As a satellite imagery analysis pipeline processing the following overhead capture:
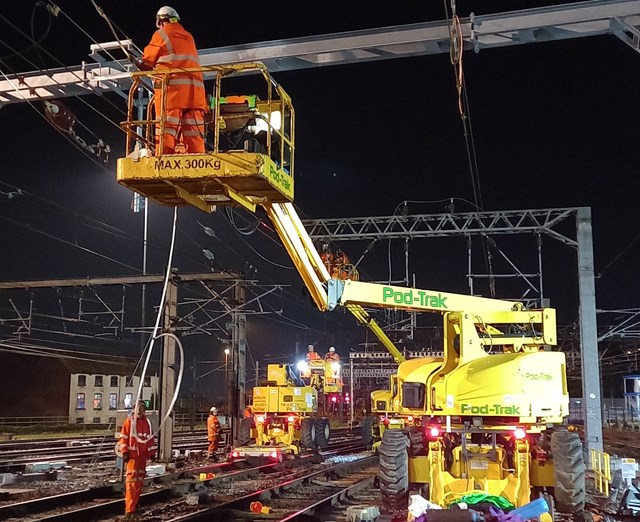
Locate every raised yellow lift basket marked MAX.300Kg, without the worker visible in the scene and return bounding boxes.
[117,64,295,212]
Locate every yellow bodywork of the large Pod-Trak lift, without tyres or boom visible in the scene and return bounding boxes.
[371,308,569,506]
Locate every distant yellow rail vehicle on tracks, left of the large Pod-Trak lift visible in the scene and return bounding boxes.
[231,364,331,461]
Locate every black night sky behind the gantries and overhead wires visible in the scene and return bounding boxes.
[0,0,640,394]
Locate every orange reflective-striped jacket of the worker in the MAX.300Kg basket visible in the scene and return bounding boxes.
[142,22,207,113]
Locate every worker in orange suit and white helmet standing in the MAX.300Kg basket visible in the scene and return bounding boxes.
[141,6,207,154]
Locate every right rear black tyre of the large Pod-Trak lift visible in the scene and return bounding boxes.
[551,431,586,514]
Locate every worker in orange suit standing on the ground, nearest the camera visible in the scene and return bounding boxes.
[117,401,158,520]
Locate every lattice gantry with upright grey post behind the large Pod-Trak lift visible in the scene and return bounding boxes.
[303,207,603,451]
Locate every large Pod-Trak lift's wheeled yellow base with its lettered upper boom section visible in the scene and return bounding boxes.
[342,281,585,512]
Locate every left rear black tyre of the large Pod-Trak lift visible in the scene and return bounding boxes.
[379,430,409,513]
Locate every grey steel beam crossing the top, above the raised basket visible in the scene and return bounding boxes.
[0,0,640,106]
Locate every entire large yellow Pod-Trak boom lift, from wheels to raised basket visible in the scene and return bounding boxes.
[117,64,584,512]
